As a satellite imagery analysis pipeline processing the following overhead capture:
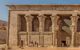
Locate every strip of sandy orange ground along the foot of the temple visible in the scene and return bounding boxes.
[9,47,80,50]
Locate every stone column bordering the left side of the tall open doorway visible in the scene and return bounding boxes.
[51,15,59,47]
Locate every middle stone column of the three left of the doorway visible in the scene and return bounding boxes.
[38,15,45,46]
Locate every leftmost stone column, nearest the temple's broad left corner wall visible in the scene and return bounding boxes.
[26,15,32,46]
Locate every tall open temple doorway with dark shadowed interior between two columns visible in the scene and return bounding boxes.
[57,15,71,47]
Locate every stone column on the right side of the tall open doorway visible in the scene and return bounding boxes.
[70,15,78,47]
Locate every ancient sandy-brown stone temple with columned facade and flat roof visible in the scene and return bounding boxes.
[7,5,80,48]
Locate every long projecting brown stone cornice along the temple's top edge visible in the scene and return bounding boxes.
[8,5,80,11]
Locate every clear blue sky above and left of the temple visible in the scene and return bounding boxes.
[0,0,80,21]
